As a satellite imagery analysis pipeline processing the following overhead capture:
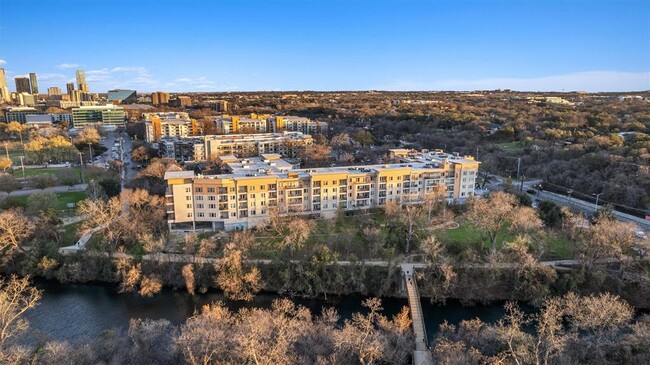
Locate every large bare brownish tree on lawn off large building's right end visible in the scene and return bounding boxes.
[466,191,542,254]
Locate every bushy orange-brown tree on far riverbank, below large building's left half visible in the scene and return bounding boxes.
[214,242,262,301]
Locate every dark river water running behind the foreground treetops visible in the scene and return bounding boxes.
[26,281,504,343]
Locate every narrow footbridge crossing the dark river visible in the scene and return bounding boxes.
[401,264,433,365]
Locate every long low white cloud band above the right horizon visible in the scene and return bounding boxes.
[382,71,650,92]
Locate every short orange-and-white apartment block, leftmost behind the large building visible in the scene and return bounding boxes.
[142,112,201,143]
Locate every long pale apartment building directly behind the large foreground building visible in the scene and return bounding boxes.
[158,132,314,161]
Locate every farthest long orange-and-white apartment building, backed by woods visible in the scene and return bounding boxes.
[214,114,327,134]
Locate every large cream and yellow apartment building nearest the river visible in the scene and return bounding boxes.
[165,151,479,230]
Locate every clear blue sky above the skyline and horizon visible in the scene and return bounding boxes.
[0,0,650,93]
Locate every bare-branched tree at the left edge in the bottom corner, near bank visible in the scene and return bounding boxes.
[0,276,41,363]
